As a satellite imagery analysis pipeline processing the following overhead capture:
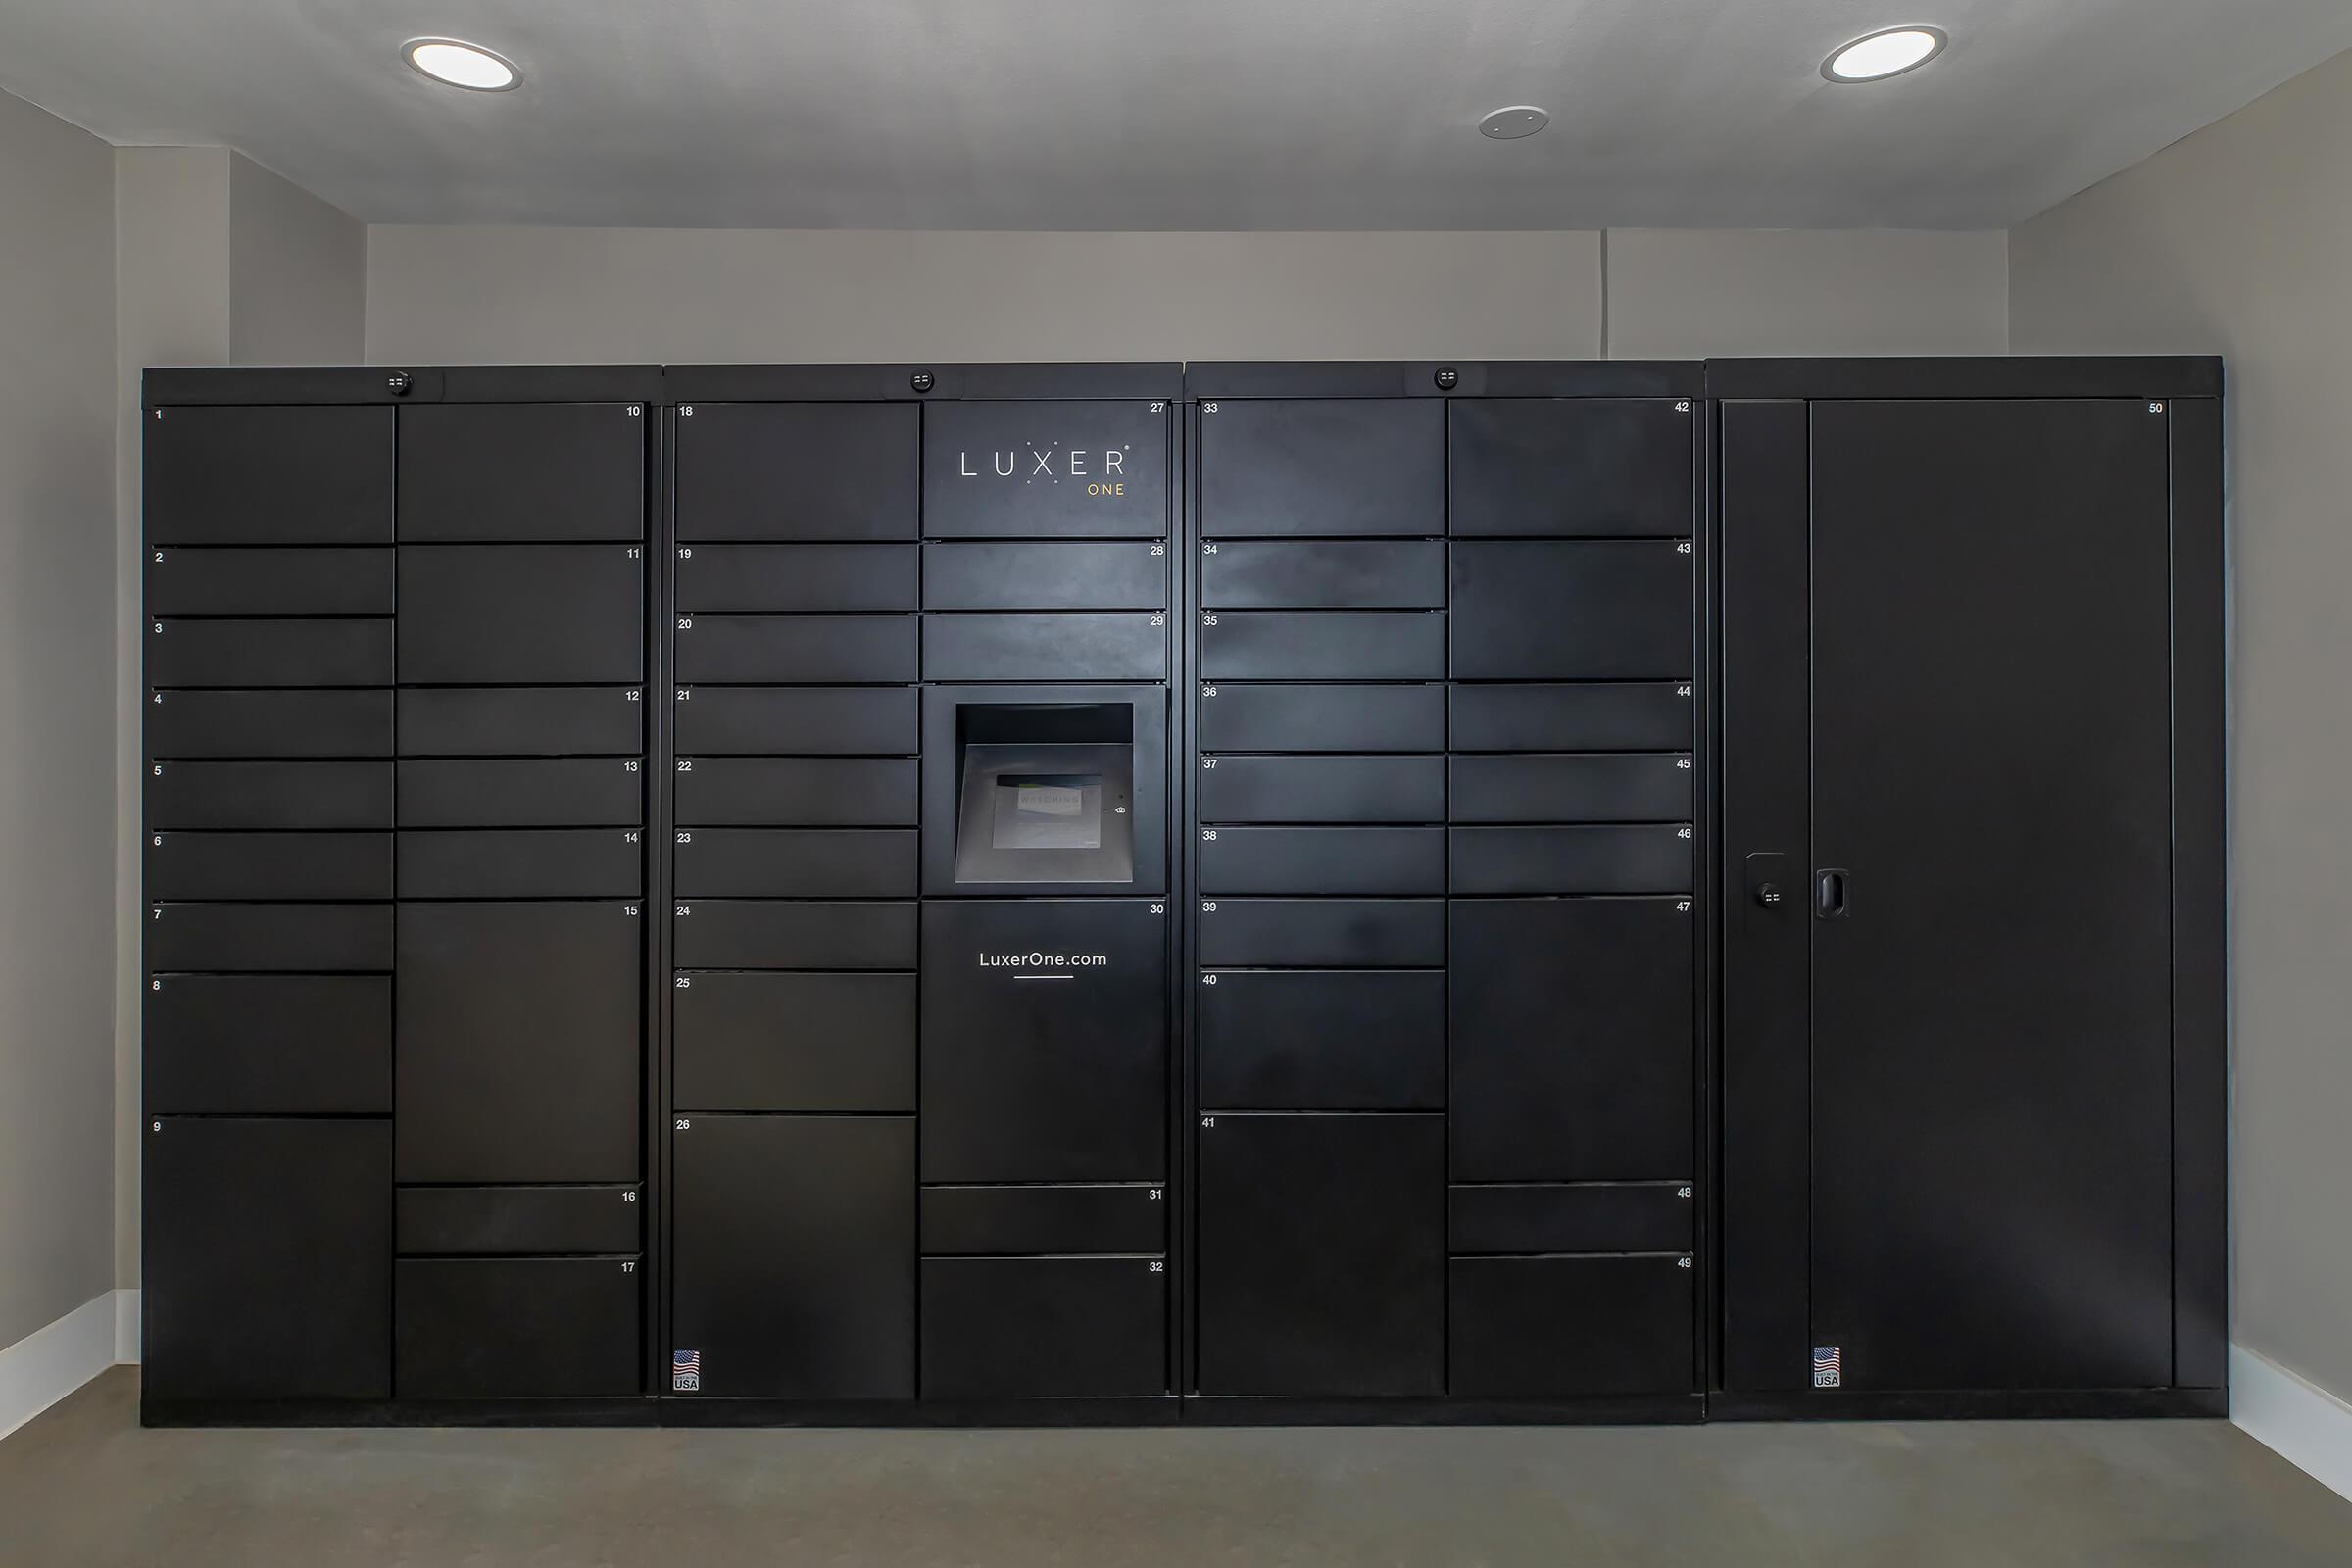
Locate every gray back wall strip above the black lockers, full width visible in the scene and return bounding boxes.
[367,225,2009,362]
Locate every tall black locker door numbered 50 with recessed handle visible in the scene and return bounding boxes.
[1809,400,2174,1390]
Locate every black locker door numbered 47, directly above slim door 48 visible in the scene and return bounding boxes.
[1446,898,1698,1183]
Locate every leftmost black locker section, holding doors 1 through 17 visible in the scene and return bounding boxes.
[143,369,661,1405]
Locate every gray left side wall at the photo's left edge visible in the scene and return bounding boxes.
[0,94,116,1348]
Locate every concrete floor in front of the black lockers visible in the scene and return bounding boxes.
[0,1368,2352,1568]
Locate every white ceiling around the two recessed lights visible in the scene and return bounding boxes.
[0,0,2352,230]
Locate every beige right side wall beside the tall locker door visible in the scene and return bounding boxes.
[2009,54,2352,1396]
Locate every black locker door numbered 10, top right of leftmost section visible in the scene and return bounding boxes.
[400,402,649,543]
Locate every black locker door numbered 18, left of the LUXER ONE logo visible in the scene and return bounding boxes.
[677,402,922,541]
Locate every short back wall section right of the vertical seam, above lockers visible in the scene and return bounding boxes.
[1609,228,2009,360]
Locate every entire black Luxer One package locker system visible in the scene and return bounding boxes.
[141,360,2225,1425]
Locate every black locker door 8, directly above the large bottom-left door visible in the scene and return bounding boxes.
[143,973,393,1116]
